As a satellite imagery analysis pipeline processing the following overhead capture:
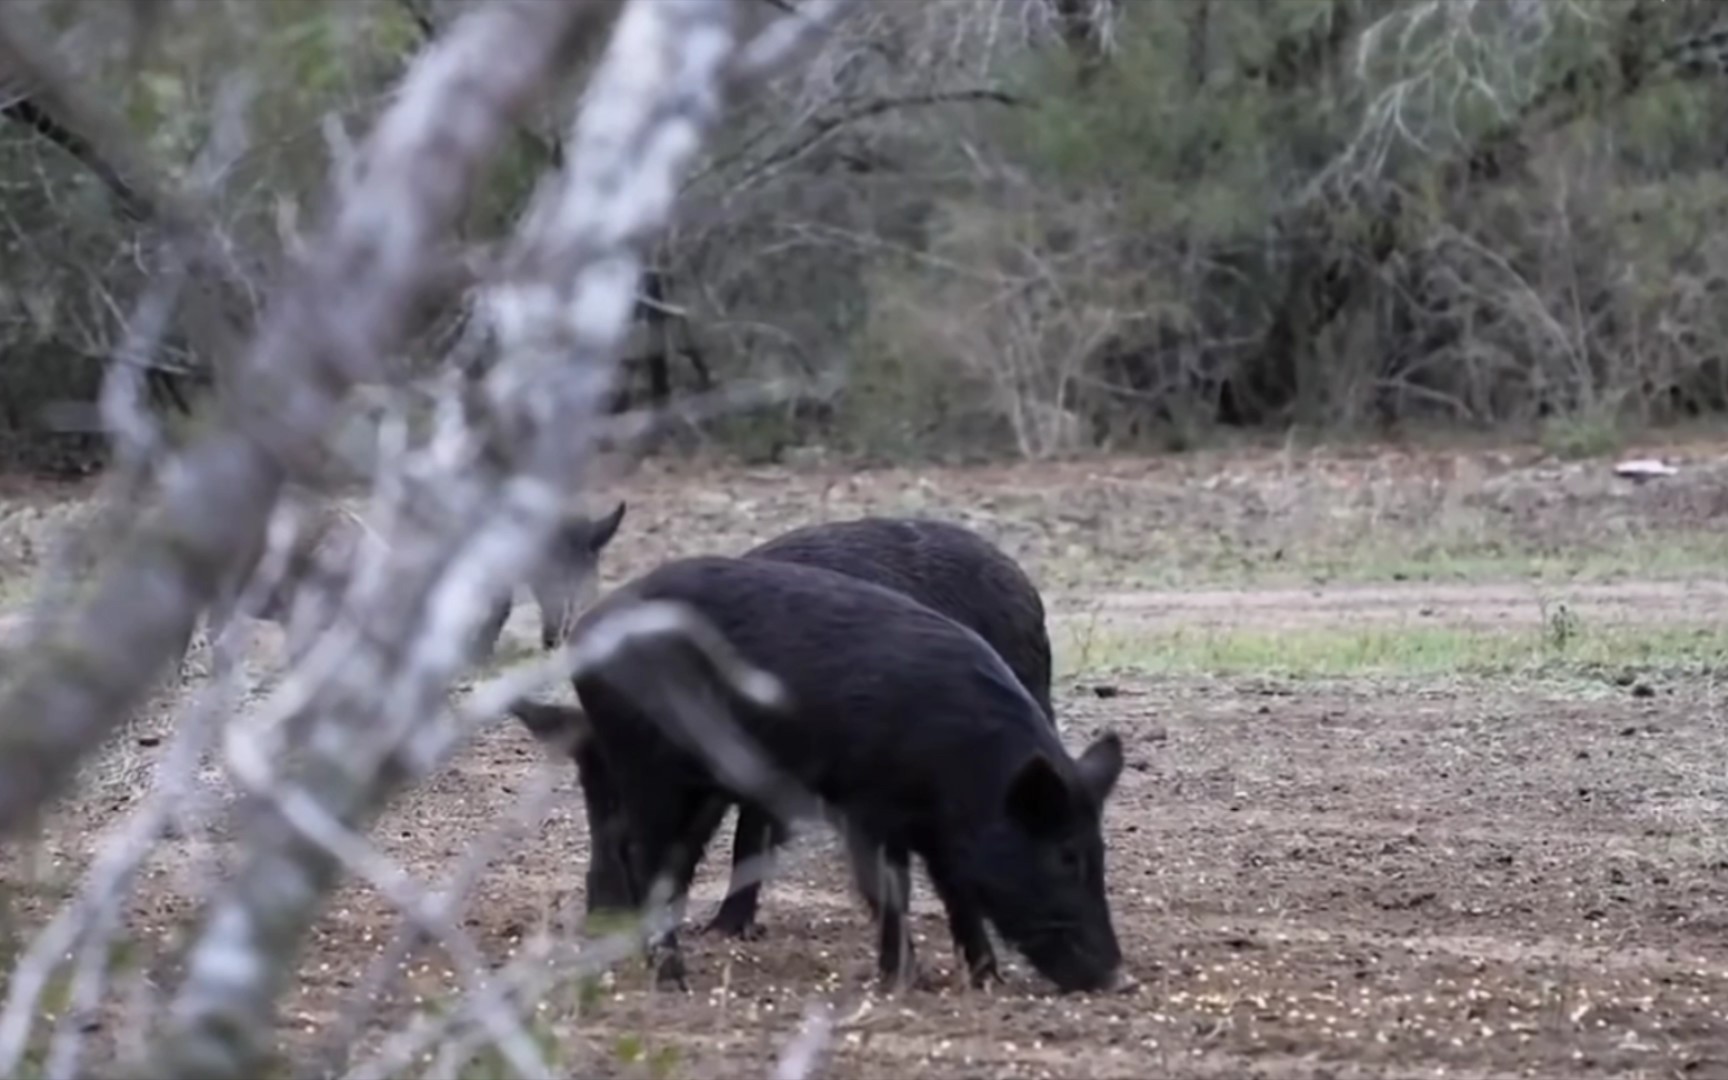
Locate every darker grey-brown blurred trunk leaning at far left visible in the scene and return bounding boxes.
[0,2,615,831]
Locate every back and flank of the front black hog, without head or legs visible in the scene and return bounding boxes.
[577,556,1068,828]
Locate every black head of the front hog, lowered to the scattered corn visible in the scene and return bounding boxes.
[966,731,1121,992]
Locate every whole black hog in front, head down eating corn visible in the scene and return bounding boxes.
[513,556,1121,990]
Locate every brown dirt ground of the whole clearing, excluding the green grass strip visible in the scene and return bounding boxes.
[0,440,1728,1080]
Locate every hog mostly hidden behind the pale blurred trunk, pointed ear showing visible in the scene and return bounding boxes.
[209,501,624,664]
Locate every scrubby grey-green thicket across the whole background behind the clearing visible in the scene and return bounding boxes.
[10,0,1728,468]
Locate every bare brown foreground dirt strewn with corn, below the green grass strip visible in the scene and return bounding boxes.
[226,656,1728,1080]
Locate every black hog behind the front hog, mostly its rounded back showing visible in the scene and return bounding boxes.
[698,517,1056,938]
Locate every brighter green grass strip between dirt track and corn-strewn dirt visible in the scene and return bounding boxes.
[1054,619,1728,679]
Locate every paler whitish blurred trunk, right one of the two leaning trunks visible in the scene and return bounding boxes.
[138,0,853,1077]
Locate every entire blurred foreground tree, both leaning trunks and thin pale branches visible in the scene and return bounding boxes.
[0,0,845,1077]
